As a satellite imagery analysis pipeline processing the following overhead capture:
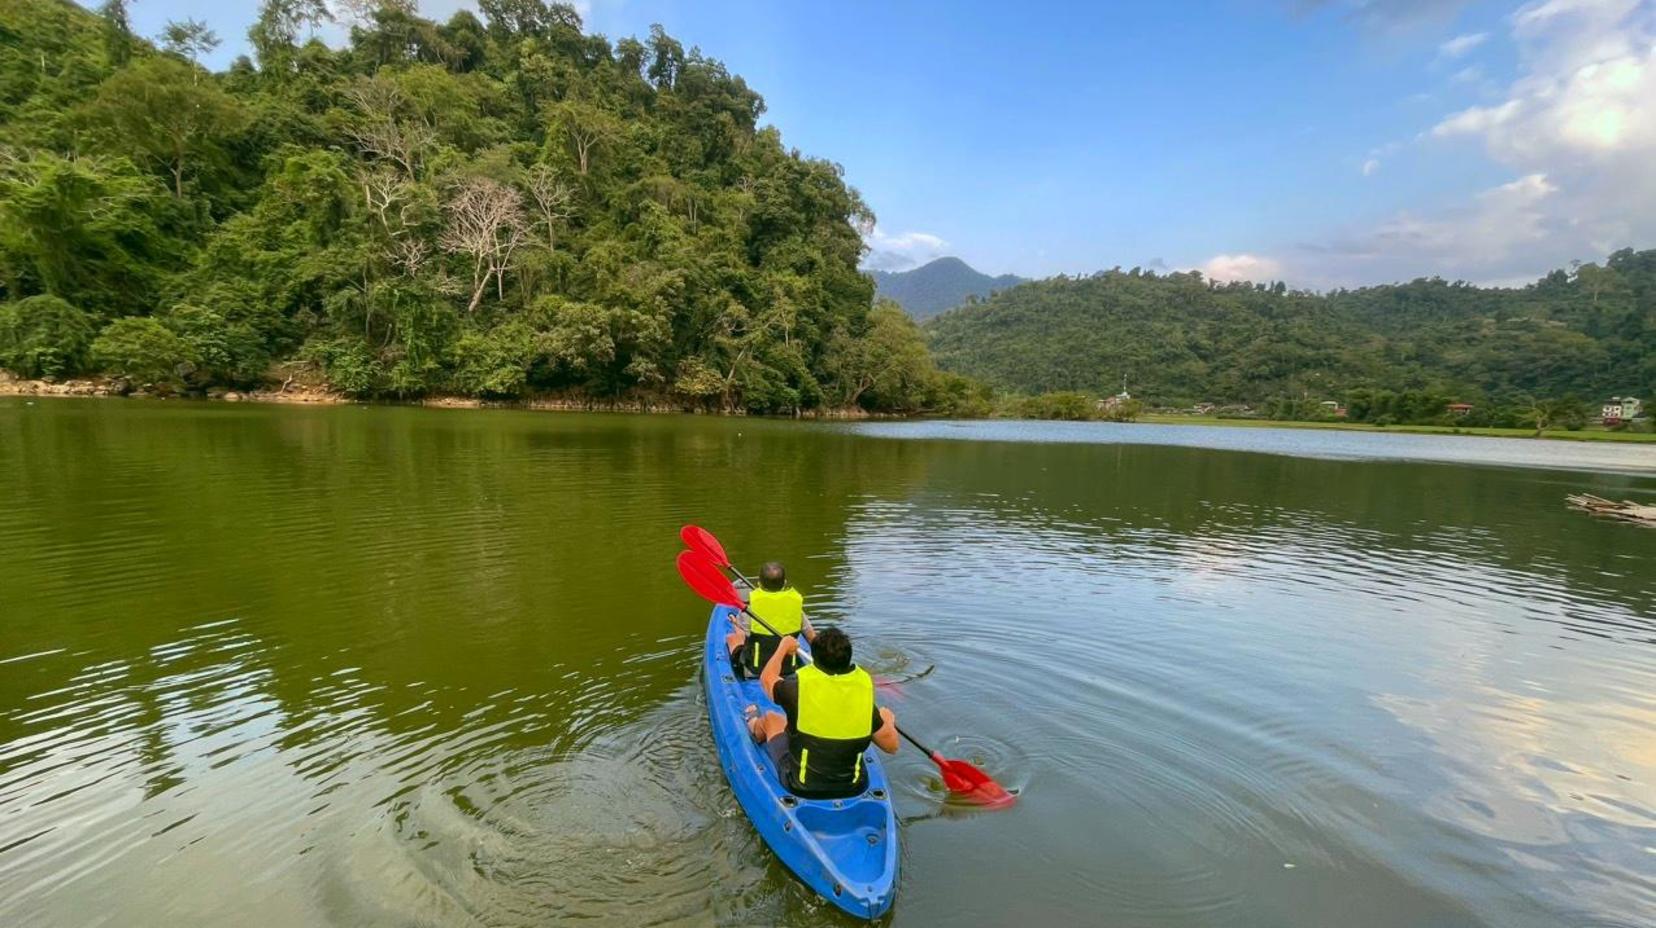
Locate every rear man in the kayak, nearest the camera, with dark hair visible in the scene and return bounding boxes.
[747,626,899,799]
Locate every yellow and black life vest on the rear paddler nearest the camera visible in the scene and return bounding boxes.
[788,665,874,794]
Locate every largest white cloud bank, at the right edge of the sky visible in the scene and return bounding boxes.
[1278,0,1656,287]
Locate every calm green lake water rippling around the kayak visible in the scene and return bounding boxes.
[0,399,1656,928]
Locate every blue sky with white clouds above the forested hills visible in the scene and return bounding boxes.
[122,0,1656,288]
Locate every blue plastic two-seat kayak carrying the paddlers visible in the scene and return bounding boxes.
[702,607,898,918]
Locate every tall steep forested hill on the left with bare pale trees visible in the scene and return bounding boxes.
[0,0,960,411]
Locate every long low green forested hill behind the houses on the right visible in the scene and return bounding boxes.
[926,250,1656,403]
